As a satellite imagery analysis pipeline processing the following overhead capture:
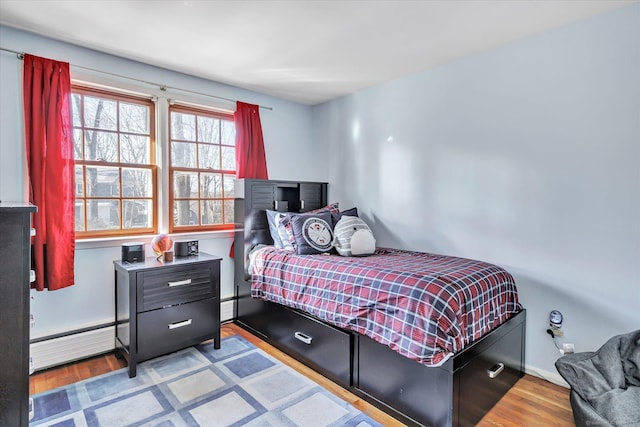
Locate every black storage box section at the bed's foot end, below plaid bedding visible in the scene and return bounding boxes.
[355,311,525,427]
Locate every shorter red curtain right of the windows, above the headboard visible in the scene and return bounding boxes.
[233,101,268,179]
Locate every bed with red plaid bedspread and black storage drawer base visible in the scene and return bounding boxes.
[235,180,525,426]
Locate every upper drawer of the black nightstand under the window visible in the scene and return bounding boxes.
[137,263,215,312]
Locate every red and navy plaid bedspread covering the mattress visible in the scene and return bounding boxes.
[251,246,522,366]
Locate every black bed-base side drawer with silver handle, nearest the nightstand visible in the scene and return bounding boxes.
[267,303,352,387]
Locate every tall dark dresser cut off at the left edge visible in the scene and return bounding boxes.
[0,203,36,426]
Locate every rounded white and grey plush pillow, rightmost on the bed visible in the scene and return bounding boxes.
[333,215,376,256]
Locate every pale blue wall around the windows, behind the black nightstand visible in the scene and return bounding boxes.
[0,26,326,338]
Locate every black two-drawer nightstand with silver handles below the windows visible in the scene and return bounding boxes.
[114,252,221,377]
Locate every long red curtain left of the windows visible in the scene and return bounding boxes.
[24,55,75,291]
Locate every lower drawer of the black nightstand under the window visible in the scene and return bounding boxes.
[138,298,220,360]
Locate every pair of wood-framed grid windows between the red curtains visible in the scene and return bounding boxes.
[72,85,236,238]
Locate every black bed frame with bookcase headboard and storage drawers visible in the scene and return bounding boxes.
[234,180,526,426]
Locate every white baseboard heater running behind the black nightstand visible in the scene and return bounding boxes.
[29,299,234,371]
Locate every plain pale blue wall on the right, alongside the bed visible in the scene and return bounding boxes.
[314,5,640,381]
